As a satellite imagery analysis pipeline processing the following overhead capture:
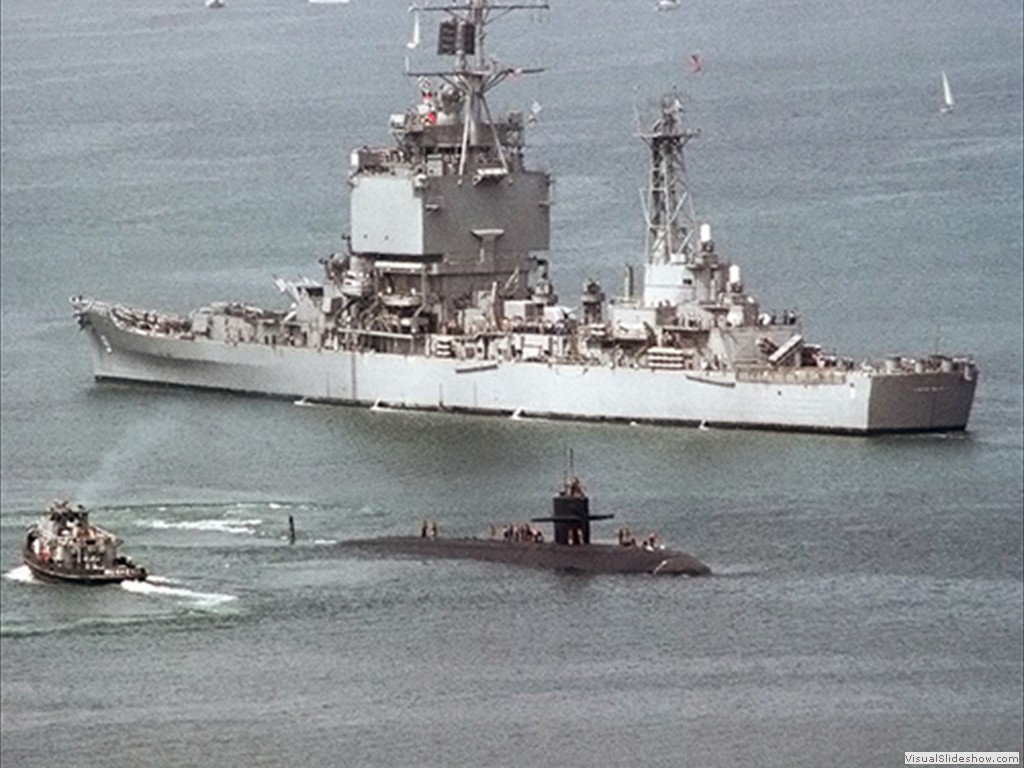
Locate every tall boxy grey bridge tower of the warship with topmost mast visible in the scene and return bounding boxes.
[349,0,552,323]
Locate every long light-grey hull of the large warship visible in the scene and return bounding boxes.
[80,303,977,434]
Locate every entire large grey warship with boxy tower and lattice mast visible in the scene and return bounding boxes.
[72,0,978,434]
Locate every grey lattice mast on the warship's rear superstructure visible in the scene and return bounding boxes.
[640,93,699,264]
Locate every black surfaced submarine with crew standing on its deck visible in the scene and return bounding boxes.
[345,476,711,577]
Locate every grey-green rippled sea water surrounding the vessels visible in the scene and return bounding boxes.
[0,0,1024,767]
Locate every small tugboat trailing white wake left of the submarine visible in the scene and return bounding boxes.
[24,501,146,585]
